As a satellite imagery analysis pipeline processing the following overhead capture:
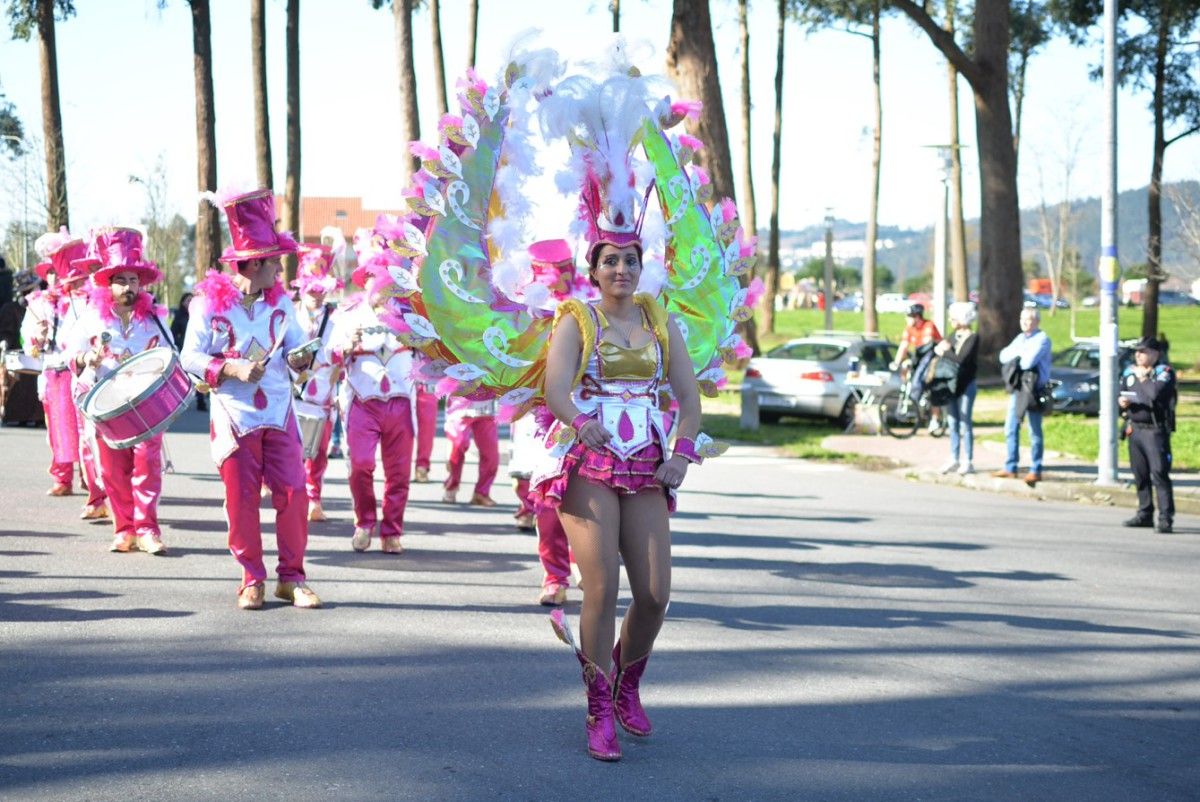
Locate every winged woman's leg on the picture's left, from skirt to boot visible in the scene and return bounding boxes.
[559,475,622,674]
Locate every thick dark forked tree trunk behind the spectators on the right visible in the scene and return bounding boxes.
[892,0,1022,360]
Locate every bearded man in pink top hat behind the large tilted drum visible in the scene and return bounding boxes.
[67,228,174,555]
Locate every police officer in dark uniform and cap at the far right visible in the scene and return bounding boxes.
[1117,337,1175,534]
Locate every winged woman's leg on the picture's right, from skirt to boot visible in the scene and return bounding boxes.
[617,490,671,669]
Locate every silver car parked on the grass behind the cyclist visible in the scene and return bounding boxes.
[744,331,900,426]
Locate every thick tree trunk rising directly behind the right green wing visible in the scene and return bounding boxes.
[667,0,758,353]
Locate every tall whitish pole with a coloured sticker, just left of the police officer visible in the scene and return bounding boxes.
[1096,0,1121,485]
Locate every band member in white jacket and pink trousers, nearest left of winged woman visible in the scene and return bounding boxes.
[334,251,415,555]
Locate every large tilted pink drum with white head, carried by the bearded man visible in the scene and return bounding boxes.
[79,348,194,448]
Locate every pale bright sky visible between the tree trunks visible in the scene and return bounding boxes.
[0,0,1200,250]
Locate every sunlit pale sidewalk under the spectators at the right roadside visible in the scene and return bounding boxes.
[821,426,1200,514]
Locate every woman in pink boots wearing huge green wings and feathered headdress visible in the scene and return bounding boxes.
[369,40,754,760]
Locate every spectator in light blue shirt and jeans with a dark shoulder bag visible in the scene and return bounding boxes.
[991,309,1050,487]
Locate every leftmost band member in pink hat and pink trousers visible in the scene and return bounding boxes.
[20,229,88,496]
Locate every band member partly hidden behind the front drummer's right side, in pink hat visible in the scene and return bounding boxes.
[292,245,342,522]
